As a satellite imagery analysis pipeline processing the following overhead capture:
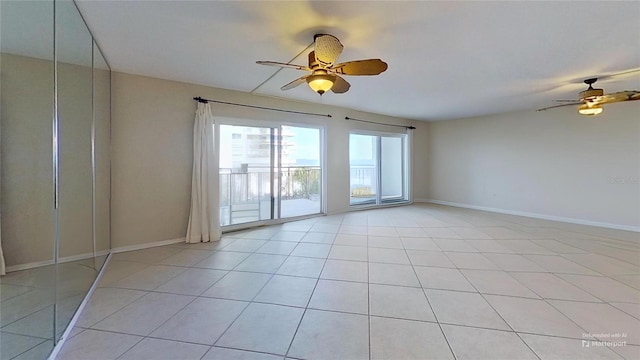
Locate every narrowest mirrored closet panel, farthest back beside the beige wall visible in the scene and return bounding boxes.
[93,42,111,271]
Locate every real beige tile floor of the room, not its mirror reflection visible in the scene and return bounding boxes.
[58,205,640,360]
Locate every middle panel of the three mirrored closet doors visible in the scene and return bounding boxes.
[55,0,97,339]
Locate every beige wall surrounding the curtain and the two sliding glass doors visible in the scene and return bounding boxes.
[111,73,426,248]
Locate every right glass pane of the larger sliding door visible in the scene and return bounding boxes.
[279,126,322,218]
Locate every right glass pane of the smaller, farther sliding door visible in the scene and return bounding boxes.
[380,136,405,203]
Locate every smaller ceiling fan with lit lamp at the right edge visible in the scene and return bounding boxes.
[538,78,640,116]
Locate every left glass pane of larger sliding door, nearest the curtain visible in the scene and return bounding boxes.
[220,125,277,226]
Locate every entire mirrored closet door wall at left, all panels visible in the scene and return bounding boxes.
[0,0,111,359]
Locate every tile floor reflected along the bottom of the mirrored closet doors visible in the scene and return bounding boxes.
[0,256,105,360]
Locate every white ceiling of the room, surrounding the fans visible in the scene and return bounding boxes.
[78,0,640,120]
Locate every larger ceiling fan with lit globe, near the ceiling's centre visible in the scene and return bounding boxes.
[256,34,387,95]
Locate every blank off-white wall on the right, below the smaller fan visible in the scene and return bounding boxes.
[424,102,640,230]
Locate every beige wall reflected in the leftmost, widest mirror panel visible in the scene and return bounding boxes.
[1,53,54,266]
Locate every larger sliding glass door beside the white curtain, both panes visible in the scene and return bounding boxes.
[219,124,322,226]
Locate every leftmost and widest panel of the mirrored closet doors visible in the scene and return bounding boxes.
[0,1,55,359]
